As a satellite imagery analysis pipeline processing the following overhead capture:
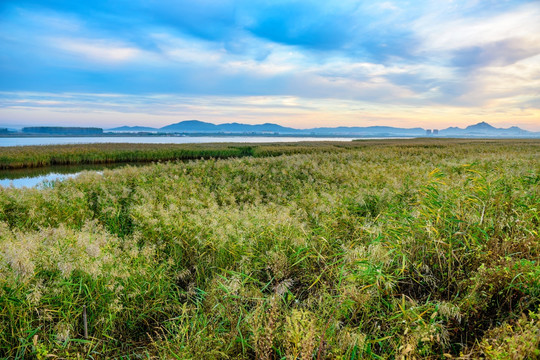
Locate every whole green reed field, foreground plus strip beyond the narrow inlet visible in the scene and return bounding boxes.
[0,139,540,359]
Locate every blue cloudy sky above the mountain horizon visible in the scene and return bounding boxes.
[0,0,540,131]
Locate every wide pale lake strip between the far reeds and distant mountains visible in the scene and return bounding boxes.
[0,136,362,146]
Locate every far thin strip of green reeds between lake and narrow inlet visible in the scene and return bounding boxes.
[0,139,534,170]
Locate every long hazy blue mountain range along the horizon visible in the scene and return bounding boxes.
[104,120,540,137]
